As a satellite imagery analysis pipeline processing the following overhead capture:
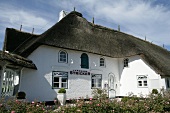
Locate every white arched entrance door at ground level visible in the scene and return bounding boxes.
[108,74,116,98]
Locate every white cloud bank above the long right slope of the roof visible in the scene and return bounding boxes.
[71,0,170,45]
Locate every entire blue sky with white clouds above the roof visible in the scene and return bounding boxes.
[0,0,170,50]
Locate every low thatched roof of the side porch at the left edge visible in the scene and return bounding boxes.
[0,51,37,69]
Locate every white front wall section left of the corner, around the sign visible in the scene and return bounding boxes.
[20,46,120,101]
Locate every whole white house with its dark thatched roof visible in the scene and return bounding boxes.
[1,11,170,101]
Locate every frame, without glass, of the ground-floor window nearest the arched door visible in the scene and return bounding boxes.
[91,73,102,89]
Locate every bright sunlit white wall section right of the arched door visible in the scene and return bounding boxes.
[119,56,163,96]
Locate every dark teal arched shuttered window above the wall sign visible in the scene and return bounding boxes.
[81,53,89,69]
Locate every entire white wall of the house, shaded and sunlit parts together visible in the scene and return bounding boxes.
[20,46,166,101]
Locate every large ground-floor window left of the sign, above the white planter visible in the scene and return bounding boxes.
[52,71,68,88]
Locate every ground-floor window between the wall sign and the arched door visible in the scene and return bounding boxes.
[91,74,102,88]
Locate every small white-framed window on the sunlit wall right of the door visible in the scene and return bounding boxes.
[137,75,148,87]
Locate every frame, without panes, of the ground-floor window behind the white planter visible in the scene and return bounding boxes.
[52,71,68,89]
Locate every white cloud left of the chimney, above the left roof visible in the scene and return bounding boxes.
[0,4,52,33]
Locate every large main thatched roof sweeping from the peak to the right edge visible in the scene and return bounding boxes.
[4,11,170,76]
